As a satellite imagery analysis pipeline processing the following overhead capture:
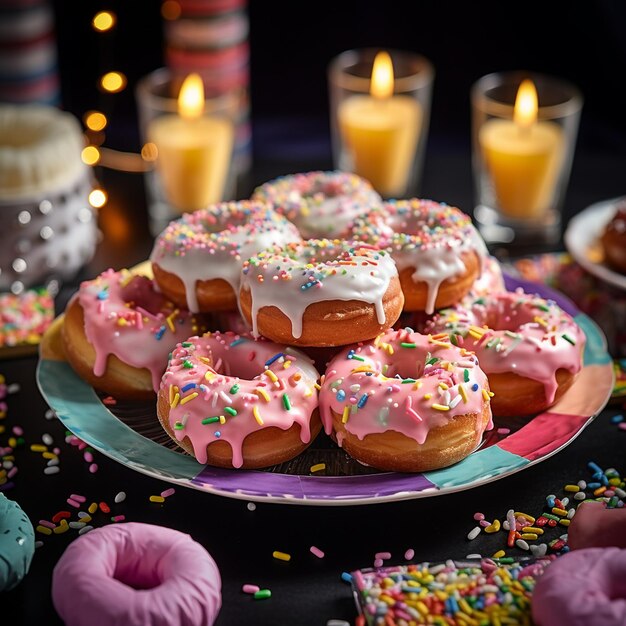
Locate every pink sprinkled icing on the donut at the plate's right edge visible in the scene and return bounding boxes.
[426,289,585,402]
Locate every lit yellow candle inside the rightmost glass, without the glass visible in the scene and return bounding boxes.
[479,80,564,219]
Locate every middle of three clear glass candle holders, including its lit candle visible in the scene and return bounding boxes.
[328,48,435,198]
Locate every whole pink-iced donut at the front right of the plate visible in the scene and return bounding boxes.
[320,329,493,472]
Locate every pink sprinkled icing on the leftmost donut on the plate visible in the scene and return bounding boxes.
[75,269,198,391]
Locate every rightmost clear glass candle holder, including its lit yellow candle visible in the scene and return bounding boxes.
[471,71,583,246]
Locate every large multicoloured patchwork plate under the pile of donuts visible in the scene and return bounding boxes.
[37,277,614,506]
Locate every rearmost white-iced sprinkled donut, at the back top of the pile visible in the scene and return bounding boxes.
[252,171,382,239]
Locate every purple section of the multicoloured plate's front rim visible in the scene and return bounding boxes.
[191,466,436,500]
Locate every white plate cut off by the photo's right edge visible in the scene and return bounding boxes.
[564,196,626,289]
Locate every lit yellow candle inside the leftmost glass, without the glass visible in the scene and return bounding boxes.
[148,74,233,212]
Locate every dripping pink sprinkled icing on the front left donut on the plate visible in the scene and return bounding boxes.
[161,332,319,467]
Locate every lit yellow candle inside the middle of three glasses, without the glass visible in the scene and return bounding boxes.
[337,52,422,198]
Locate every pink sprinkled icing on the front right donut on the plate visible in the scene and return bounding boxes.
[320,329,493,444]
